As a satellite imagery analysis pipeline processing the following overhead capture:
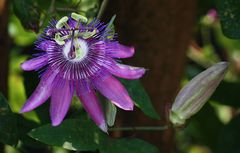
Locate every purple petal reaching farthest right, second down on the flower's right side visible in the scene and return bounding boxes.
[107,62,145,79]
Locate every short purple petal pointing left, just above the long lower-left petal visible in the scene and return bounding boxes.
[21,54,48,71]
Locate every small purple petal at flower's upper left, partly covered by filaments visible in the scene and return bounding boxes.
[36,40,56,51]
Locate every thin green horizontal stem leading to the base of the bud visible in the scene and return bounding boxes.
[108,125,169,131]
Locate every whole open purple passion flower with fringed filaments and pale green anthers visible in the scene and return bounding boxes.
[21,13,145,132]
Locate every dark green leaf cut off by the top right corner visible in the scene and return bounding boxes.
[215,0,240,39]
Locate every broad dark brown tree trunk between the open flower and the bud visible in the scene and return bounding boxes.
[103,0,196,153]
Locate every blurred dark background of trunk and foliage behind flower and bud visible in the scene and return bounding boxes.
[0,0,240,153]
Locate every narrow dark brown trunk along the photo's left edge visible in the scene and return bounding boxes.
[0,0,9,97]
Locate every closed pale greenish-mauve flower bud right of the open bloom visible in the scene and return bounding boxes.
[169,62,228,125]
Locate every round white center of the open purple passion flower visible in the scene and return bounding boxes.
[63,38,89,62]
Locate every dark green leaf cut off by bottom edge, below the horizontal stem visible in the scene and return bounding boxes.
[100,139,159,153]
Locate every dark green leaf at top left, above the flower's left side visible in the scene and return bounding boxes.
[13,0,40,32]
